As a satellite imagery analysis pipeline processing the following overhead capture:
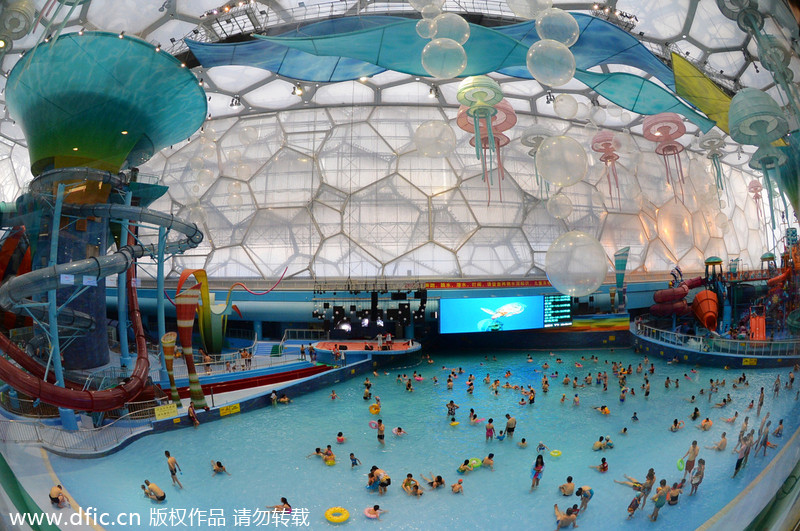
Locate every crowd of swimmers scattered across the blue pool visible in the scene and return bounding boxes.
[79,349,800,529]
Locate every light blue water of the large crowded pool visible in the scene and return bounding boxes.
[51,351,800,530]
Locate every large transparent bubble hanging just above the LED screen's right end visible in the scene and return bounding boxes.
[545,231,608,297]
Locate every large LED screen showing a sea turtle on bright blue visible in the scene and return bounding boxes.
[439,295,572,334]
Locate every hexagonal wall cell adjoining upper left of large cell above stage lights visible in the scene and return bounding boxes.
[318,122,396,193]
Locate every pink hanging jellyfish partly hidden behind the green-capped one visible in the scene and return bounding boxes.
[456,100,517,204]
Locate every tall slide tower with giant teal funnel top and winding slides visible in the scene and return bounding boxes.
[0,32,206,428]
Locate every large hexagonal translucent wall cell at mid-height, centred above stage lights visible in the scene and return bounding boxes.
[344,174,430,262]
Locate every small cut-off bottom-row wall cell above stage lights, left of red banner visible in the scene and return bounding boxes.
[311,234,383,278]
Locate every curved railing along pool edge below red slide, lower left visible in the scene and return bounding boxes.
[0,412,152,453]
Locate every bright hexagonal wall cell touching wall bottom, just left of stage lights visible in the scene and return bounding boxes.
[242,208,321,279]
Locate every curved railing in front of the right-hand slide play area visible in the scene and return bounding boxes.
[632,322,800,357]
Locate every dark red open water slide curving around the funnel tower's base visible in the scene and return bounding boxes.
[0,235,150,411]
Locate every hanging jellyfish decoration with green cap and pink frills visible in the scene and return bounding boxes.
[456,76,517,206]
